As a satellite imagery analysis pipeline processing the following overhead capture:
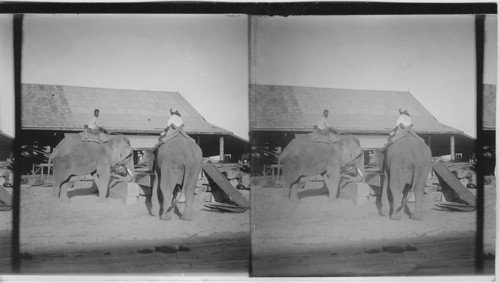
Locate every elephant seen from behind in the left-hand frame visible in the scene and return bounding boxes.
[141,134,203,221]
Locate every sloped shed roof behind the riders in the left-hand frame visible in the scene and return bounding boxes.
[21,84,232,135]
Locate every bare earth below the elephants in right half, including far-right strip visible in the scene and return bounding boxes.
[251,182,495,276]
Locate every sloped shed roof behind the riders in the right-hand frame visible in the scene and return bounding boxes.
[249,84,463,134]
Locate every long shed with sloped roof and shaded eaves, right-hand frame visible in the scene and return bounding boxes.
[249,84,475,166]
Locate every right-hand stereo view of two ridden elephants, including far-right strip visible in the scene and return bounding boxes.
[249,15,497,277]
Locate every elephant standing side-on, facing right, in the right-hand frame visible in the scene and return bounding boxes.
[278,134,364,202]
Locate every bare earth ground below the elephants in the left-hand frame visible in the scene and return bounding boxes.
[15,187,250,274]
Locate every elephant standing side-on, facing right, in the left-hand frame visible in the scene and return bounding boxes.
[48,135,134,202]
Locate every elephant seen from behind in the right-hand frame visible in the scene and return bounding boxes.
[377,134,432,220]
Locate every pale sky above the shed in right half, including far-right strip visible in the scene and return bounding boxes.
[251,16,497,137]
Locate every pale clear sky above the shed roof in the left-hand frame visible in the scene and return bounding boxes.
[22,15,248,139]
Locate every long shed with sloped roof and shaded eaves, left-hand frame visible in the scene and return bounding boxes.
[21,84,249,169]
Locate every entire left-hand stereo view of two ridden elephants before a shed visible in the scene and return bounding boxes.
[8,15,250,275]
